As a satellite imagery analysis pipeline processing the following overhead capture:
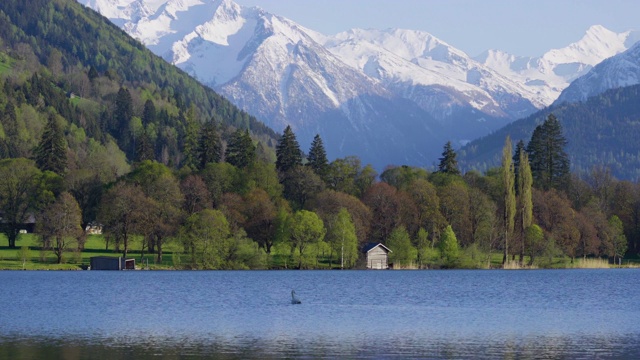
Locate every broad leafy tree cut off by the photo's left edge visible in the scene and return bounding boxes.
[0,158,48,249]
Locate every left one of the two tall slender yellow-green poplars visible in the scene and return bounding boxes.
[501,136,516,265]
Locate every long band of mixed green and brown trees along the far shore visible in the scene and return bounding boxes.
[0,115,640,269]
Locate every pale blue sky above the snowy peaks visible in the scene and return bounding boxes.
[235,0,640,56]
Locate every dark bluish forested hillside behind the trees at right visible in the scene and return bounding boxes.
[459,85,640,180]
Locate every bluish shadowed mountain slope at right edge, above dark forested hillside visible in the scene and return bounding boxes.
[556,43,640,103]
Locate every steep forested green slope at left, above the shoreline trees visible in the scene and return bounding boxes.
[0,0,277,167]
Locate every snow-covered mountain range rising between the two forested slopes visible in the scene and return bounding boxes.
[79,0,640,169]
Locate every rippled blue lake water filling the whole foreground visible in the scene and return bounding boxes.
[0,269,640,360]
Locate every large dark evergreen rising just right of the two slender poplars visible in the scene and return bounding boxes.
[527,114,569,190]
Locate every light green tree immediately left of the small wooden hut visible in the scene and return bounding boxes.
[327,208,358,269]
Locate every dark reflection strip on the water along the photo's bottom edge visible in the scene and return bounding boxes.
[0,334,640,360]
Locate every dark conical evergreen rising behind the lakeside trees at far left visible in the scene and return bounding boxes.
[34,114,67,175]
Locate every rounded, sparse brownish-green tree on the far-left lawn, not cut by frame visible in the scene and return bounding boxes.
[38,192,83,264]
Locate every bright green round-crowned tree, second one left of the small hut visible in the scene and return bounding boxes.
[289,210,326,269]
